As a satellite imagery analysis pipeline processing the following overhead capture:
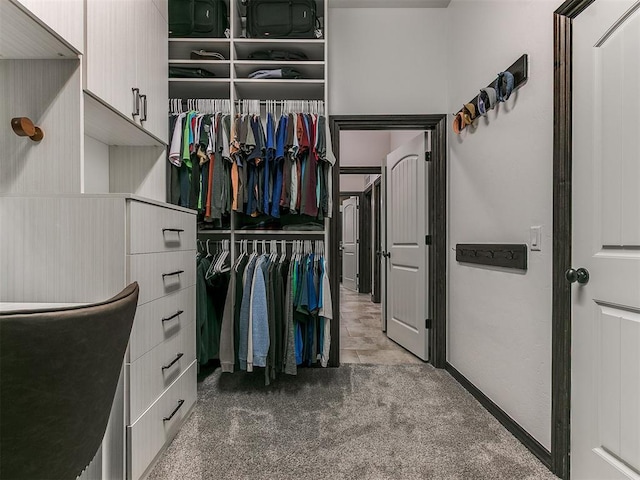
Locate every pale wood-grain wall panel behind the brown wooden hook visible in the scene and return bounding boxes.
[0,60,82,194]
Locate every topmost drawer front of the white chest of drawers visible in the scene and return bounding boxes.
[127,201,196,254]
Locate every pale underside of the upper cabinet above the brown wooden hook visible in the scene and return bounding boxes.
[0,0,79,60]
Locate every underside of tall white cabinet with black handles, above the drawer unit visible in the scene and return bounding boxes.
[84,90,166,148]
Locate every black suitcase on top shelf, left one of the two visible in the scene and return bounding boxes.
[169,0,229,38]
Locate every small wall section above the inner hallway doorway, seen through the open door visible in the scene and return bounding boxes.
[340,130,390,167]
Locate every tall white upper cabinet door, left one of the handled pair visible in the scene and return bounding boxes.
[86,0,139,122]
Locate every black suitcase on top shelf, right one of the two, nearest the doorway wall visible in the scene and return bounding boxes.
[246,0,317,38]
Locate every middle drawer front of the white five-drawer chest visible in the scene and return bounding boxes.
[127,286,196,363]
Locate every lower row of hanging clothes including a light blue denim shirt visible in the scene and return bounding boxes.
[218,241,333,385]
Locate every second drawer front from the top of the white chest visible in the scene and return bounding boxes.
[127,250,196,305]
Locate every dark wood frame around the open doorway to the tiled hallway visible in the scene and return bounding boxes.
[329,114,448,368]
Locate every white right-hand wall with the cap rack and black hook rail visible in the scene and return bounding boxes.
[446,0,562,449]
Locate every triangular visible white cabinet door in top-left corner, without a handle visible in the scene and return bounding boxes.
[13,0,84,52]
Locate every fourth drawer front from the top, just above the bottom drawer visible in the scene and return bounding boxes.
[127,322,196,422]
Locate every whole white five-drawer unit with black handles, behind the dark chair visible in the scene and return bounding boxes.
[0,195,196,480]
